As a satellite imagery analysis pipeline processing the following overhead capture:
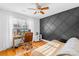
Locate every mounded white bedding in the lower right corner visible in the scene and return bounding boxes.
[57,37,79,56]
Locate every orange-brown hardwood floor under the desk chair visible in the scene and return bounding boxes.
[0,40,47,56]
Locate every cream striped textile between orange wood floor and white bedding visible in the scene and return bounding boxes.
[32,41,64,56]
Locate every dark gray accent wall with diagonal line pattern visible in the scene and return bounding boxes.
[40,7,79,41]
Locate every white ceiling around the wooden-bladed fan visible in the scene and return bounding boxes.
[0,3,79,18]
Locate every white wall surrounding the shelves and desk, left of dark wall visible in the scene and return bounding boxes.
[0,10,40,50]
